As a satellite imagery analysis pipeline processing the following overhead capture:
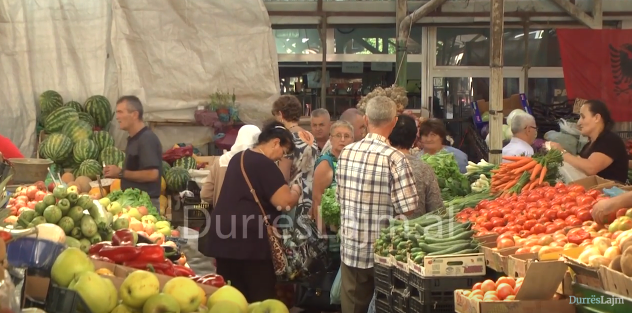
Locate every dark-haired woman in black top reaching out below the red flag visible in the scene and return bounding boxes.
[551,100,628,183]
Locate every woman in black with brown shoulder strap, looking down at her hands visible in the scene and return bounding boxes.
[208,122,301,303]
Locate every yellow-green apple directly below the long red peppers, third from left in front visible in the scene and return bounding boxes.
[119,271,160,309]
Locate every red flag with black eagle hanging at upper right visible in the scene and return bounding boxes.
[557,29,632,122]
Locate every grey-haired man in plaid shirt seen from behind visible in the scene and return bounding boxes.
[336,96,419,313]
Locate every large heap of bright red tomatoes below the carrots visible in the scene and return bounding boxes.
[456,183,615,238]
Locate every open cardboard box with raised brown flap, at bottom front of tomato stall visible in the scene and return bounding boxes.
[454,261,575,313]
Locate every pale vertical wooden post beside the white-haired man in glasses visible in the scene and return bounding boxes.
[489,0,505,164]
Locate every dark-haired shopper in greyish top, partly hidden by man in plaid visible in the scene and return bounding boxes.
[388,114,443,217]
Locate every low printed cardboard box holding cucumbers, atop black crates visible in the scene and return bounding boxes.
[408,253,486,277]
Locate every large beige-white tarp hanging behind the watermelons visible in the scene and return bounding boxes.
[0,0,279,155]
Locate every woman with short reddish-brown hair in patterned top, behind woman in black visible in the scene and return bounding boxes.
[272,95,318,217]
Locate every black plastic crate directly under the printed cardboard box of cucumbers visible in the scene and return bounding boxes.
[408,273,483,304]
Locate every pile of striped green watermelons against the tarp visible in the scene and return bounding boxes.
[39,90,125,180]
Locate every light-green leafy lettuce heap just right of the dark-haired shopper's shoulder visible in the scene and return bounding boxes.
[421,150,471,201]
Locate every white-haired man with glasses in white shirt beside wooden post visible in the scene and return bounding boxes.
[503,114,538,162]
